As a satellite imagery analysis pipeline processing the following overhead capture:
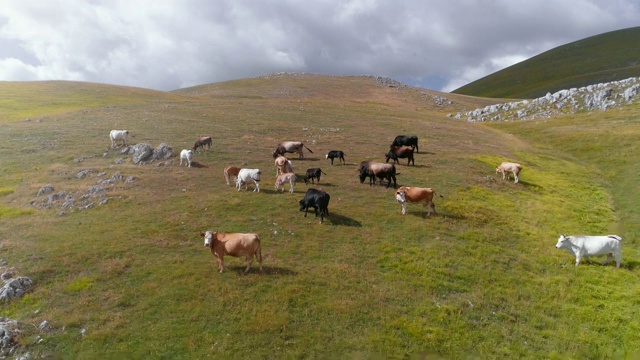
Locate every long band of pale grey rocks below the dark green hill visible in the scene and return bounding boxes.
[447,77,640,122]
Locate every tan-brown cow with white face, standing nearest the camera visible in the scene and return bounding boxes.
[200,230,262,274]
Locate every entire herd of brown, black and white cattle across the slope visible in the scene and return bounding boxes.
[109,130,622,273]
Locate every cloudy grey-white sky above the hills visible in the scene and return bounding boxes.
[0,0,640,91]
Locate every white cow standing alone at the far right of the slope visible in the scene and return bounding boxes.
[556,235,622,268]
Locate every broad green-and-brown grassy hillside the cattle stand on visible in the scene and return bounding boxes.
[0,75,640,358]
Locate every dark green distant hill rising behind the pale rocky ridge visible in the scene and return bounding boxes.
[453,27,640,99]
